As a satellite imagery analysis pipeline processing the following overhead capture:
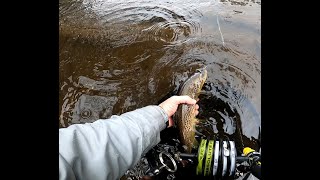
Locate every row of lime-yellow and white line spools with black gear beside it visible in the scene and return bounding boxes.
[190,139,261,179]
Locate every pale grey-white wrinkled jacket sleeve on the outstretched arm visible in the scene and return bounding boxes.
[59,105,168,180]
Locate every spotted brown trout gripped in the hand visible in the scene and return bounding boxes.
[176,68,207,153]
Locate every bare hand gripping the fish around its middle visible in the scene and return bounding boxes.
[159,96,199,127]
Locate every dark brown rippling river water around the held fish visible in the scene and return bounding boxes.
[59,0,261,179]
